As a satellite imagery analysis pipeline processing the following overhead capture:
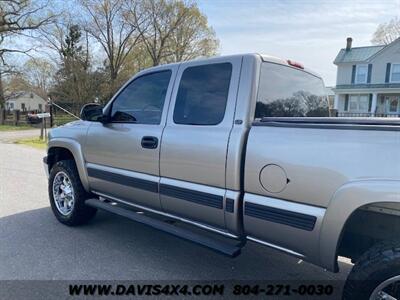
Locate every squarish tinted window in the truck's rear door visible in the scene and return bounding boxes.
[174,63,232,125]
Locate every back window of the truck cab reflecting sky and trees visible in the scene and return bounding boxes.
[255,63,329,118]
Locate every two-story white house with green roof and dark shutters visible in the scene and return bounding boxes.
[333,38,400,117]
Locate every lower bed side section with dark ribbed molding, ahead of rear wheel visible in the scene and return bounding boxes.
[243,193,326,264]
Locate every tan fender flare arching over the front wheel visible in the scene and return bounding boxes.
[47,138,89,192]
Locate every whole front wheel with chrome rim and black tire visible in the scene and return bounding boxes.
[49,160,96,226]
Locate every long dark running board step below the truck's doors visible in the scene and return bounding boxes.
[85,199,242,257]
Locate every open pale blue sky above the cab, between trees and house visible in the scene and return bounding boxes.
[198,0,400,86]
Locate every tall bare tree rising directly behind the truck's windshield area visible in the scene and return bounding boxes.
[80,0,141,92]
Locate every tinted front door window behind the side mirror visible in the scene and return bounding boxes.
[111,71,171,124]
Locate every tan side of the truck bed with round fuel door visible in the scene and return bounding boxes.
[244,118,400,266]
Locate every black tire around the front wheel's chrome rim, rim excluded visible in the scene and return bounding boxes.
[48,160,97,226]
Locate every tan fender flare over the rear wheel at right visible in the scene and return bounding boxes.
[319,180,400,272]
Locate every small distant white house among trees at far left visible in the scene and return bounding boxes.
[6,91,46,111]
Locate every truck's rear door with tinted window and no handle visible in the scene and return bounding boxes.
[160,56,242,227]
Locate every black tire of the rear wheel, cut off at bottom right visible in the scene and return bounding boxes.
[343,240,400,300]
